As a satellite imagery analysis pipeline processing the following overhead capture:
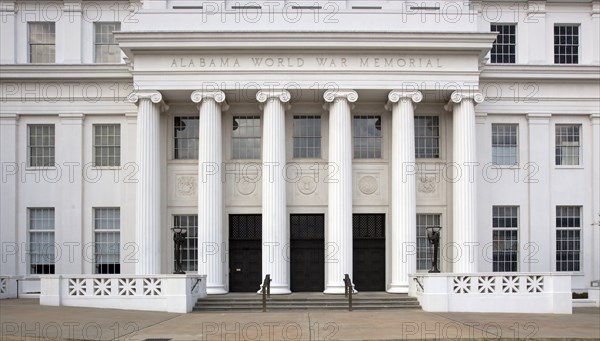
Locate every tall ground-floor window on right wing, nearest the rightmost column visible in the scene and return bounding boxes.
[492,206,519,272]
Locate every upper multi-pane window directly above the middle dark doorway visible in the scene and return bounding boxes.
[294,116,321,158]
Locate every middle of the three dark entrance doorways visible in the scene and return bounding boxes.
[290,214,325,292]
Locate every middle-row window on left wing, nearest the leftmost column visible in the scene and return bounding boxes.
[94,124,121,167]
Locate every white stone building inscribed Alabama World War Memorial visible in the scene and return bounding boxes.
[0,0,600,293]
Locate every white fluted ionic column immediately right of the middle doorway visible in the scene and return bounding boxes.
[323,90,358,294]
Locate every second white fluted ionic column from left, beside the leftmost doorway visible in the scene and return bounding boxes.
[192,90,228,295]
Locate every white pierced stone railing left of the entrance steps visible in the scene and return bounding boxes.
[40,275,206,313]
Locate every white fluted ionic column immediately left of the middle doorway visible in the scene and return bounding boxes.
[256,90,291,294]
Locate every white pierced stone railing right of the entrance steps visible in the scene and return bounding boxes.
[409,272,572,314]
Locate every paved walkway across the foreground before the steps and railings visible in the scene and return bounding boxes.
[0,299,600,341]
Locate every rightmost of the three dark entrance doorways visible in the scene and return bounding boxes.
[352,214,385,291]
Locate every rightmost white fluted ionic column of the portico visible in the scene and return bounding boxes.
[442,91,483,273]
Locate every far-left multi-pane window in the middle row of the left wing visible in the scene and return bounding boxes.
[27,124,54,167]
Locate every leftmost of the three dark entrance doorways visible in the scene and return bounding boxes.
[229,214,262,292]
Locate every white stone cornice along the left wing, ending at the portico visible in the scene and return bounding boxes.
[0,64,133,81]
